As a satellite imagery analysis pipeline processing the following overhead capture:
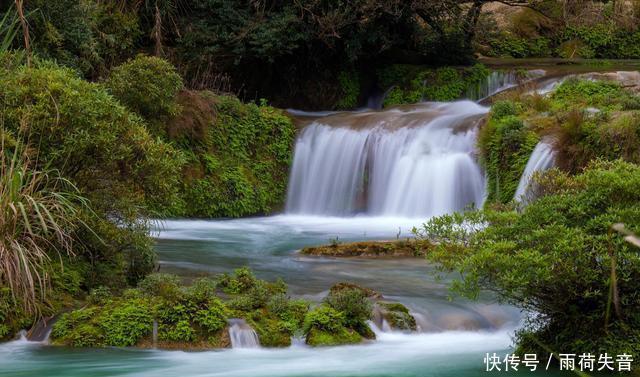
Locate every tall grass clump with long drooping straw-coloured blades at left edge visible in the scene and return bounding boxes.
[0,135,88,315]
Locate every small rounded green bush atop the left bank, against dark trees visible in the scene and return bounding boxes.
[105,55,183,120]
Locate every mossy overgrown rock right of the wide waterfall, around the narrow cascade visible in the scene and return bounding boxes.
[479,79,640,203]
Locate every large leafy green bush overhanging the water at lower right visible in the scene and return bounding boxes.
[424,161,640,354]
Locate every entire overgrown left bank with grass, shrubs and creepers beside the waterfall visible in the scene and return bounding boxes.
[0,49,294,337]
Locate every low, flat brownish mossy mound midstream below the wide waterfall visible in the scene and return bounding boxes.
[301,240,429,258]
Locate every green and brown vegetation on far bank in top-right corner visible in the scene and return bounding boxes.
[475,0,640,59]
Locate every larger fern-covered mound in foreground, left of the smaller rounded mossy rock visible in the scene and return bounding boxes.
[51,268,308,349]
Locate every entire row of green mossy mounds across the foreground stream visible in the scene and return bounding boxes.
[51,268,415,349]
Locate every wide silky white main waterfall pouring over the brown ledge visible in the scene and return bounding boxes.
[286,101,487,217]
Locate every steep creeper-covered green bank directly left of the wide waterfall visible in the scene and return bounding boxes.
[165,92,295,217]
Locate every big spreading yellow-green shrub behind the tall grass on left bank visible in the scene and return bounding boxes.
[0,62,182,287]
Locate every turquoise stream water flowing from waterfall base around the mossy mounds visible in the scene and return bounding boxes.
[0,216,568,377]
